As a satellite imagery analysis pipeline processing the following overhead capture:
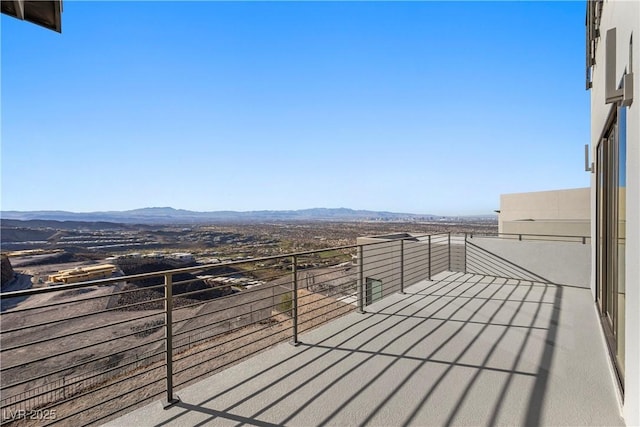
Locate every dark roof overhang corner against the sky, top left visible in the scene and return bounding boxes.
[2,0,62,33]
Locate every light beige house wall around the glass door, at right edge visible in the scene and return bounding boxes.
[592,0,640,425]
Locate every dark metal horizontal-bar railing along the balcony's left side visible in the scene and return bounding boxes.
[0,233,461,425]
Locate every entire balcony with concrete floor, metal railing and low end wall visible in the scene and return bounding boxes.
[1,233,624,426]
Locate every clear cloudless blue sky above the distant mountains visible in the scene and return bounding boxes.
[1,1,589,214]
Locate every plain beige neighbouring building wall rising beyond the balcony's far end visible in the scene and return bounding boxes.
[498,188,591,236]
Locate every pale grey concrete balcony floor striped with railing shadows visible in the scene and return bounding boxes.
[109,272,624,426]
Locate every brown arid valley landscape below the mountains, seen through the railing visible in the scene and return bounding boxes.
[2,219,497,425]
